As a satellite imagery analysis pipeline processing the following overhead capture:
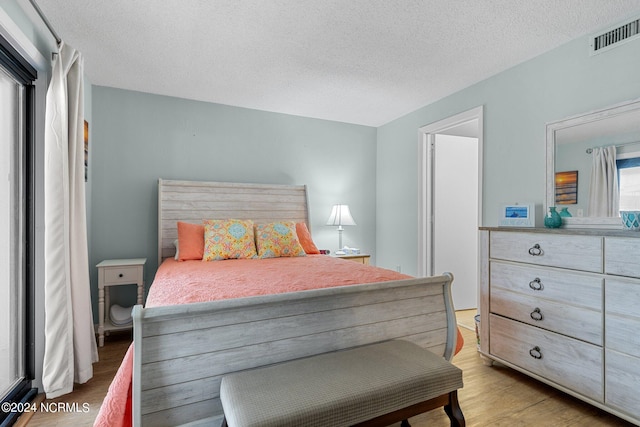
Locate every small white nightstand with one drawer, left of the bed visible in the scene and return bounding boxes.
[96,258,147,347]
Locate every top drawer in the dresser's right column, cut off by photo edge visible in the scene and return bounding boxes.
[604,237,640,278]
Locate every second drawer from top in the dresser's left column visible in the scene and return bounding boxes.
[490,261,604,311]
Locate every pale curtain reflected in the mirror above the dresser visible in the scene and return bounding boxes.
[588,146,620,217]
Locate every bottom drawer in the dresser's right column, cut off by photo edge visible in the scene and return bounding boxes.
[605,350,640,417]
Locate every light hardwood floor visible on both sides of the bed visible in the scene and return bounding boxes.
[17,310,632,427]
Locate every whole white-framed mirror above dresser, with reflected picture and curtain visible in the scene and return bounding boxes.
[546,100,640,226]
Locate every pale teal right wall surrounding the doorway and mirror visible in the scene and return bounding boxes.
[376,30,640,274]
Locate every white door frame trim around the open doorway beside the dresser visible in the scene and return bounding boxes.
[418,105,484,277]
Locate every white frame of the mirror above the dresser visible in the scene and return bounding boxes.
[544,98,640,229]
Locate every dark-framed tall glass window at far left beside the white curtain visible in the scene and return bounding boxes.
[0,37,36,426]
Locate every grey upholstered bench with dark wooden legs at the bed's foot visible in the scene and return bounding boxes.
[220,340,465,427]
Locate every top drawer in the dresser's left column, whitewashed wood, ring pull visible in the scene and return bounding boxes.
[489,231,602,273]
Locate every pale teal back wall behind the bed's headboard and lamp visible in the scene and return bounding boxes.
[89,86,376,312]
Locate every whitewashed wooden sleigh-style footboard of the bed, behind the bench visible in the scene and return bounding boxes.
[133,274,457,426]
